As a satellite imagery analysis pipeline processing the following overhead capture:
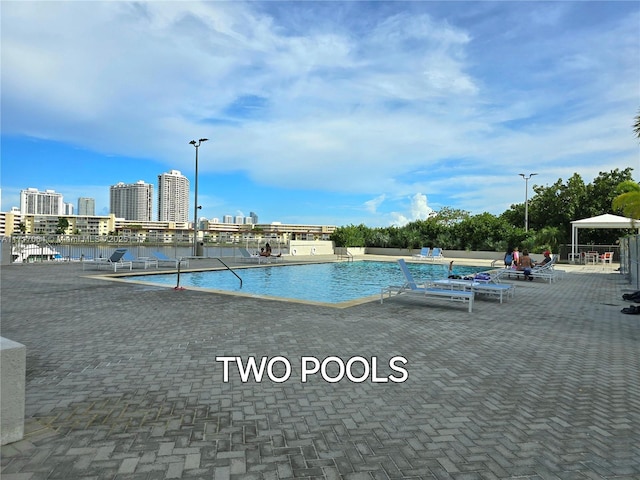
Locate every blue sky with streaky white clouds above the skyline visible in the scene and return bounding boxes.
[0,0,640,226]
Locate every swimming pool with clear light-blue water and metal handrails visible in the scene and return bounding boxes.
[126,260,486,305]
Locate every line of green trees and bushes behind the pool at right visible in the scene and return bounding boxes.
[331,168,640,253]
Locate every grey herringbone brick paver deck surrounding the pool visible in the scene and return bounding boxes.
[0,257,640,480]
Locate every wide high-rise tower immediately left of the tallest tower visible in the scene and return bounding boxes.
[109,180,153,222]
